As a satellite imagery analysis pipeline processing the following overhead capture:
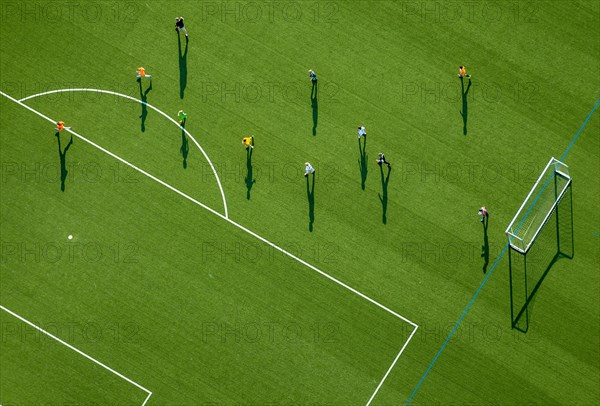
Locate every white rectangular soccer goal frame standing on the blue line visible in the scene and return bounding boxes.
[506,157,571,254]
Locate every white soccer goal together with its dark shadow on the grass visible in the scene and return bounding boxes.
[506,157,574,332]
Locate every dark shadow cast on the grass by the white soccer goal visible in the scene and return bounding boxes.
[508,184,575,333]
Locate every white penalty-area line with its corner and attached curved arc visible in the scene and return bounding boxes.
[0,89,419,405]
